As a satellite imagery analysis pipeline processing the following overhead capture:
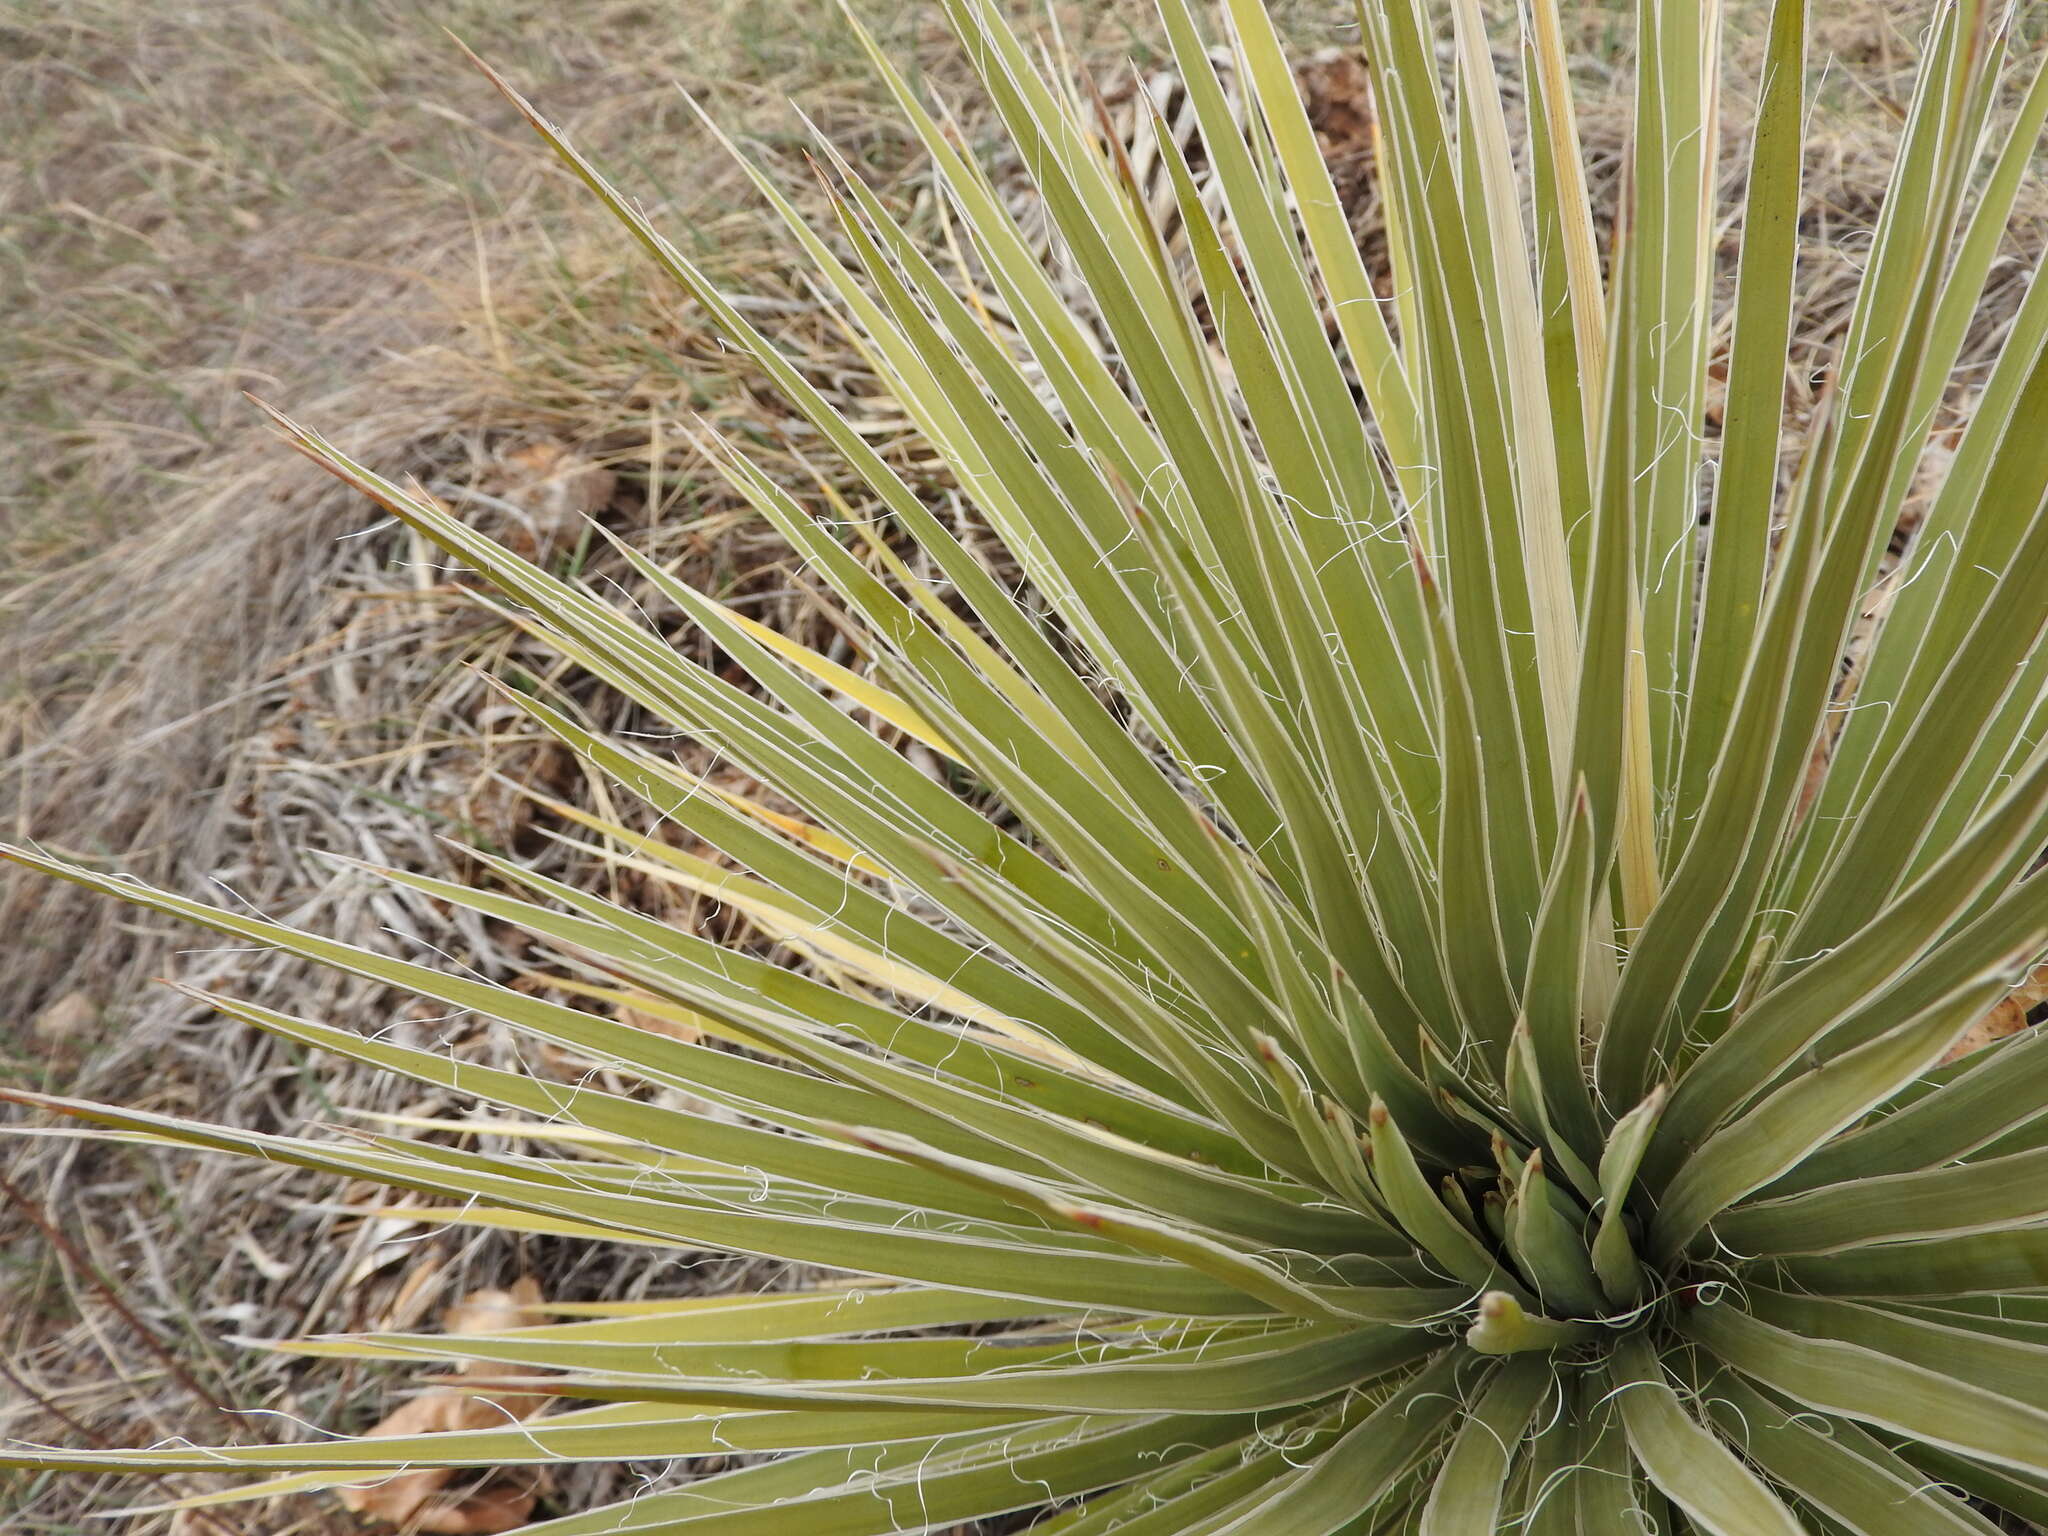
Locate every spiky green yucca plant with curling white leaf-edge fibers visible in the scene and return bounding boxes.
[10,0,2048,1536]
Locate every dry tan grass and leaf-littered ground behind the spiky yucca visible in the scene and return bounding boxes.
[0,0,2042,1532]
